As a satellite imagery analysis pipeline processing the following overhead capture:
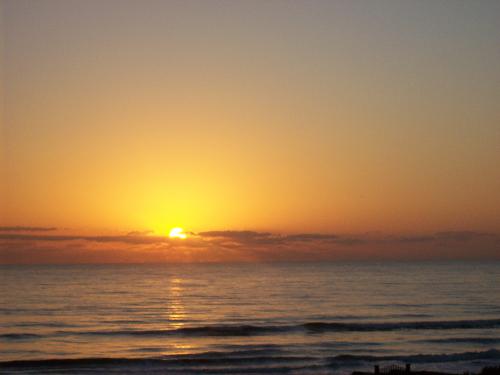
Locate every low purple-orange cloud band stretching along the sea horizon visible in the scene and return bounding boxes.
[0,226,500,264]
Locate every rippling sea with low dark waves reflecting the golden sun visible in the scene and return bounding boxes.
[0,262,500,374]
